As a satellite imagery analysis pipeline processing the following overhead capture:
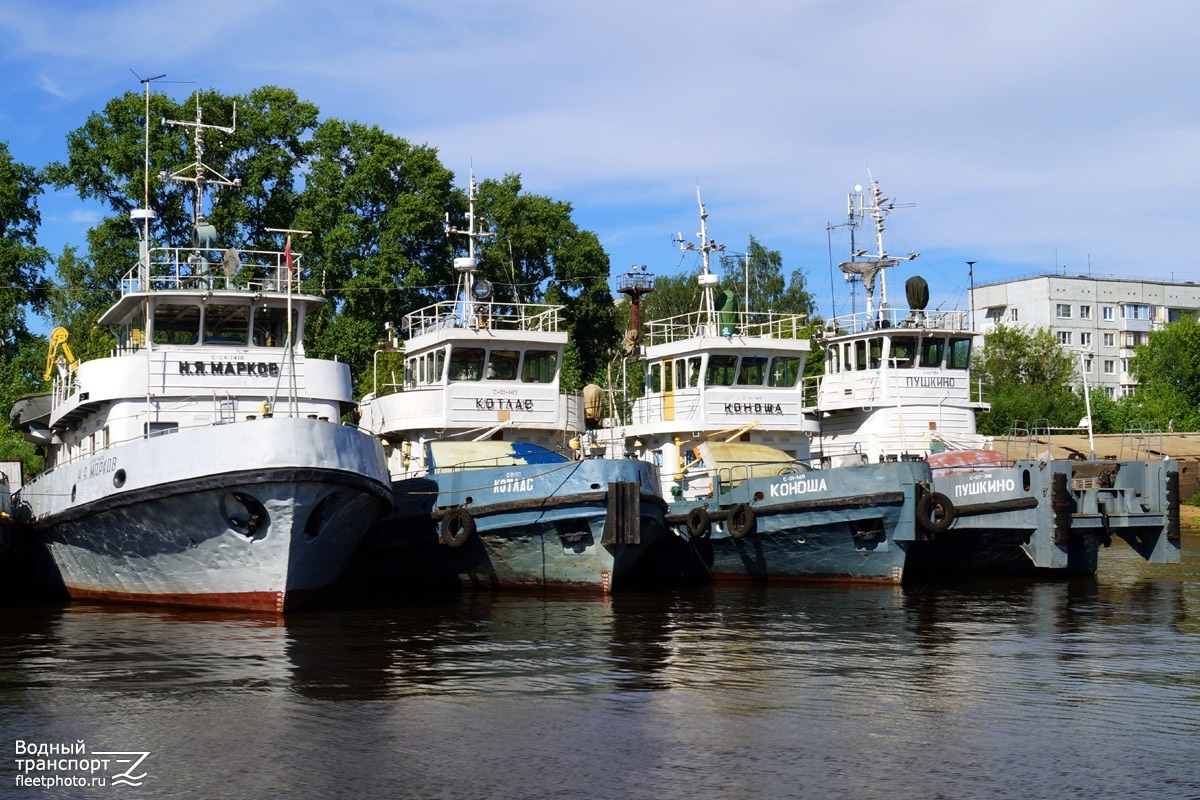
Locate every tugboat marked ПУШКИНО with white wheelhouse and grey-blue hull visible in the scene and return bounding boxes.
[806,178,1180,577]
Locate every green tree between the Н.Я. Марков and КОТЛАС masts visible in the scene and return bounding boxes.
[296,120,453,391]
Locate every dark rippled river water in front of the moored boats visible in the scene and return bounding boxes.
[0,534,1200,800]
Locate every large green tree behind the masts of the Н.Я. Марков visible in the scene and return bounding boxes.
[44,86,317,340]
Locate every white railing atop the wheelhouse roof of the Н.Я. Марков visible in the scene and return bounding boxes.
[121,247,302,296]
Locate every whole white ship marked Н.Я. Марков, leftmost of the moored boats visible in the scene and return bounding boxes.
[13,84,391,613]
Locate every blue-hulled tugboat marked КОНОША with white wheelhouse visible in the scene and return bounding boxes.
[600,191,930,583]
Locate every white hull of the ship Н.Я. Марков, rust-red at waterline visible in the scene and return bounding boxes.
[22,419,391,612]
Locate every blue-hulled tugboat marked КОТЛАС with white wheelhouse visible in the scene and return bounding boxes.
[347,179,686,591]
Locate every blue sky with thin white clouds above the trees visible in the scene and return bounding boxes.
[0,0,1200,315]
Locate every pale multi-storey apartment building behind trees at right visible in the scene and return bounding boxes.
[970,275,1200,397]
